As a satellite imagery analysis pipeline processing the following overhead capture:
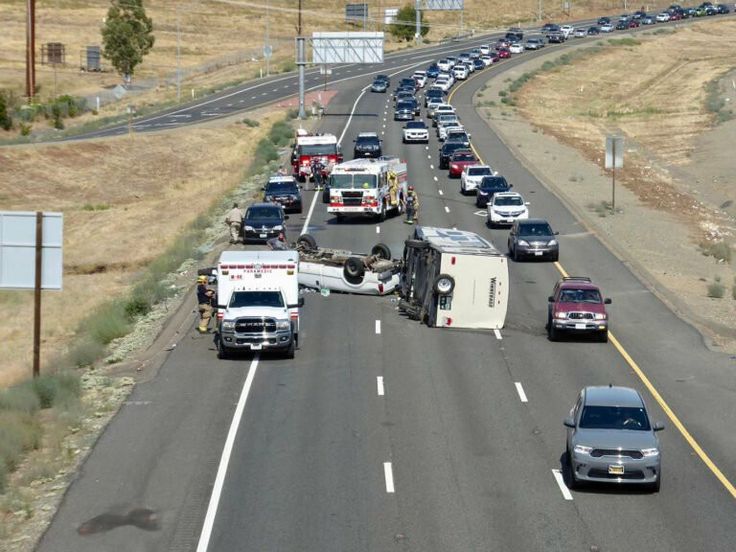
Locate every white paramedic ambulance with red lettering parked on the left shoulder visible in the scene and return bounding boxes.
[217,251,304,358]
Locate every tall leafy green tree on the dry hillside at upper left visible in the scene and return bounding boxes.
[102,0,155,80]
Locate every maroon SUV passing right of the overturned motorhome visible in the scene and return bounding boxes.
[547,276,611,343]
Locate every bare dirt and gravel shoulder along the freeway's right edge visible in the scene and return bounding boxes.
[474,42,736,352]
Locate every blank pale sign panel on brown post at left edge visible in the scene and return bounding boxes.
[0,211,64,290]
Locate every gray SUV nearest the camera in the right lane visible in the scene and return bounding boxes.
[564,385,664,492]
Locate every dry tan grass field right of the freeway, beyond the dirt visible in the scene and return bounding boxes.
[517,21,736,232]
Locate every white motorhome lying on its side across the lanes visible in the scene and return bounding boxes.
[399,226,509,330]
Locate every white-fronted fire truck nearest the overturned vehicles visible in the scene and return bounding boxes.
[327,157,408,221]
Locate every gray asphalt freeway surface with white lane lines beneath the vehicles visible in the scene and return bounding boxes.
[39,16,736,552]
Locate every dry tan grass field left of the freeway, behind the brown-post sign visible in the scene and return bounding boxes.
[0,106,282,386]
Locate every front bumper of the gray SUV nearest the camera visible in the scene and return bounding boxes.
[572,453,661,485]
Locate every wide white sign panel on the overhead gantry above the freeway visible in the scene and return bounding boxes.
[312,33,383,65]
